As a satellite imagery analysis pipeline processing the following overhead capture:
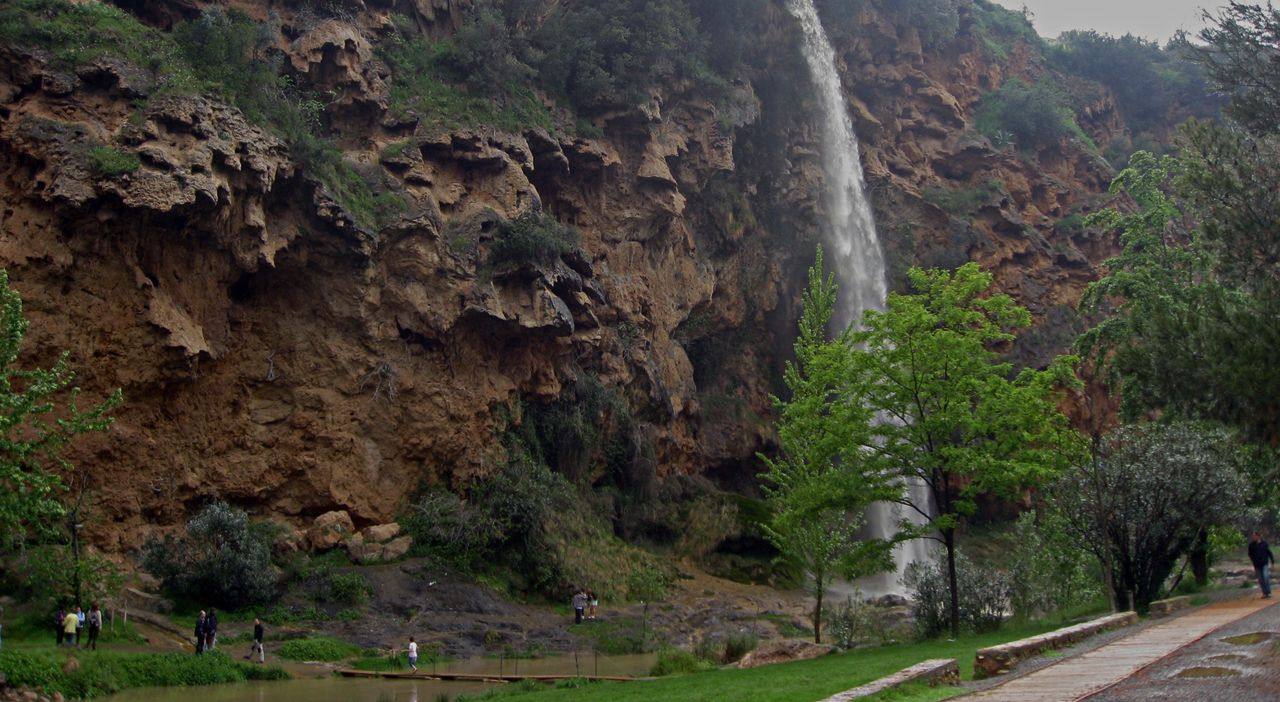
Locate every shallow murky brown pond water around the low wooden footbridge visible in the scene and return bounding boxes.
[104,653,658,702]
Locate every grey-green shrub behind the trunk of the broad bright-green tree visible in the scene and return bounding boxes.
[902,553,1010,638]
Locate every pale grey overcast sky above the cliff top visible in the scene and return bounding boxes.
[996,0,1225,44]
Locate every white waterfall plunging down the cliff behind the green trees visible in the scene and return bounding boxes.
[787,0,932,596]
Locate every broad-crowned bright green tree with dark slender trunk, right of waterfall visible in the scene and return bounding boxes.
[847,263,1079,635]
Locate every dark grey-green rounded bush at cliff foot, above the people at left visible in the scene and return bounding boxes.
[142,502,278,608]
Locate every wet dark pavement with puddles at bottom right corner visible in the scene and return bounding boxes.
[1088,596,1280,702]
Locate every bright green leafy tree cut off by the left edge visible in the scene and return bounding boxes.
[0,270,120,548]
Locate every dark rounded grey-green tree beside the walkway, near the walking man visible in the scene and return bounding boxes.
[1051,421,1245,611]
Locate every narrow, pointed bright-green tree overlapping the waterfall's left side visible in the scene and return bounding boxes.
[760,249,897,643]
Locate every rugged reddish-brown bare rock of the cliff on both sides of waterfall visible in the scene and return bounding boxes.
[0,0,1124,551]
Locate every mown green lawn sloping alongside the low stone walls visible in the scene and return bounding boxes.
[455,623,1085,702]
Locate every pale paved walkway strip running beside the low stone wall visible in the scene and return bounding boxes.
[963,597,1276,702]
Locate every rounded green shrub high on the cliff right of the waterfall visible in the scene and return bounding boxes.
[975,78,1092,151]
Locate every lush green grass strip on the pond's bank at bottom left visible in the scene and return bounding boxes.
[0,647,289,698]
